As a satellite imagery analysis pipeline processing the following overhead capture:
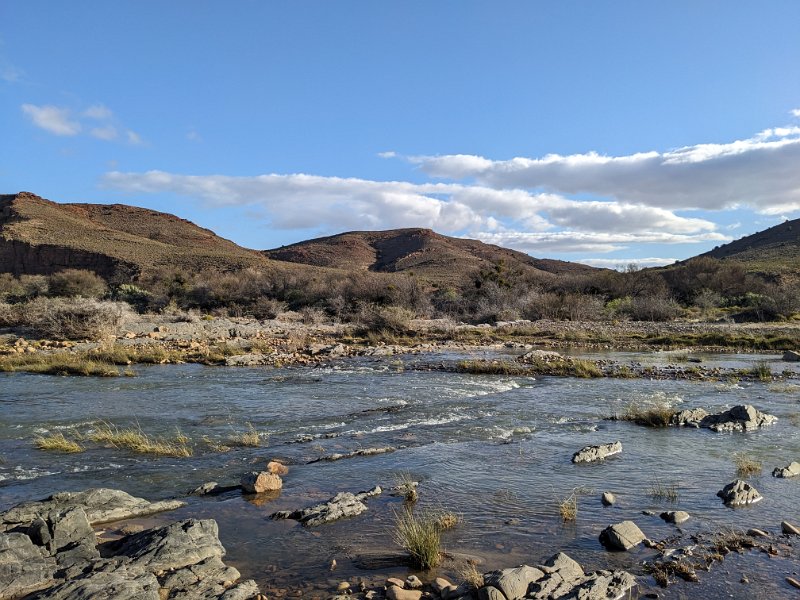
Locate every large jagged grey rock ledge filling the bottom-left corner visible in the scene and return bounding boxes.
[0,490,259,600]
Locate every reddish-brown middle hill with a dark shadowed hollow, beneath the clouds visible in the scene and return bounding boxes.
[264,229,597,283]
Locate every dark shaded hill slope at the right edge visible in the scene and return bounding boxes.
[700,219,800,277]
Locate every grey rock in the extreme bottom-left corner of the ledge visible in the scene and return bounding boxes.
[0,533,56,598]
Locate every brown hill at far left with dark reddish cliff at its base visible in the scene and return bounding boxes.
[0,192,269,280]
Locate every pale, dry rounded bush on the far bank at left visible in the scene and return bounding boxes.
[23,298,130,340]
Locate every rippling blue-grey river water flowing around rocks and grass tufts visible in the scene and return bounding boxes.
[0,353,800,598]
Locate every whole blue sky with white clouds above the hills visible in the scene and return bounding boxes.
[0,0,800,267]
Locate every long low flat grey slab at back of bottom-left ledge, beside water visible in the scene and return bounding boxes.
[0,488,186,531]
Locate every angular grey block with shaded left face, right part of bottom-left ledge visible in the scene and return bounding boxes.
[110,519,225,572]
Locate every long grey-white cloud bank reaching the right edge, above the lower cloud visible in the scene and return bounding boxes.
[408,122,800,214]
